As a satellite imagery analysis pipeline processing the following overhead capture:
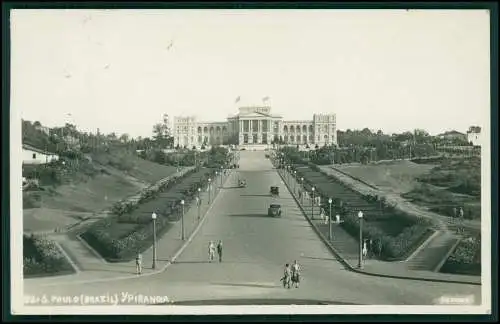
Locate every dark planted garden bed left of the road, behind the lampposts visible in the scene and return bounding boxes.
[81,168,215,262]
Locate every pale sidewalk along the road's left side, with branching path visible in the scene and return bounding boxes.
[25,171,232,285]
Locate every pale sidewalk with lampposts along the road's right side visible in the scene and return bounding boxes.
[278,170,481,285]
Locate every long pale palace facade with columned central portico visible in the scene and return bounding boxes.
[172,106,337,148]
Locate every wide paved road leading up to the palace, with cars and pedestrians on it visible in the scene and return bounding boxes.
[23,151,481,305]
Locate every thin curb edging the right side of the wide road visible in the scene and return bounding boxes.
[278,171,481,286]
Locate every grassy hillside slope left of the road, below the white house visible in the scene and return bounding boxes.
[23,151,180,232]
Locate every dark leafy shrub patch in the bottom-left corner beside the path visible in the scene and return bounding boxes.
[23,235,74,277]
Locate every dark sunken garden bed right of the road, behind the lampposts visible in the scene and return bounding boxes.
[294,165,432,260]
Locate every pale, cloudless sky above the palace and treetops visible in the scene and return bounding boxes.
[11,10,490,137]
